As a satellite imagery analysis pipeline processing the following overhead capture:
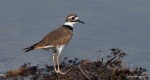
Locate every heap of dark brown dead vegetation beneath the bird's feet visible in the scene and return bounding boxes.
[0,48,148,80]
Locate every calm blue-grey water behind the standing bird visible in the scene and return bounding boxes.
[0,0,150,72]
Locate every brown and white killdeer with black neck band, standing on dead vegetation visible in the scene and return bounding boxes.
[23,14,84,74]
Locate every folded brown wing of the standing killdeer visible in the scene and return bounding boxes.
[35,27,73,48]
